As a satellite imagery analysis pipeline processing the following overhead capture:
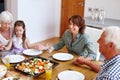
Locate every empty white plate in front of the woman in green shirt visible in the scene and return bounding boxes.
[53,53,73,61]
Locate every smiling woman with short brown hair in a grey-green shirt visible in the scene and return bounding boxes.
[48,15,96,60]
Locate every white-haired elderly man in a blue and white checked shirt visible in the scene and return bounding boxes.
[75,26,120,80]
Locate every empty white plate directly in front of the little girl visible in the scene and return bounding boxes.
[23,49,42,56]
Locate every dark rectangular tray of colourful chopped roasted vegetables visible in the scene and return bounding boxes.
[14,56,59,77]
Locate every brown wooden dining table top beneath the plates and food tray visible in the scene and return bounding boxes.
[0,50,101,80]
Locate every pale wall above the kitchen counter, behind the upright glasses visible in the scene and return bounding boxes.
[85,0,120,20]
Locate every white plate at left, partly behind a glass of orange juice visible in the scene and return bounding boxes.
[3,55,25,63]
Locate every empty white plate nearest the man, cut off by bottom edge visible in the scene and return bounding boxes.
[58,70,85,80]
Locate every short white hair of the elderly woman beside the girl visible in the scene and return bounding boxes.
[0,11,13,22]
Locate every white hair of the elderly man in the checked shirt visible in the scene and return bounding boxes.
[103,26,120,50]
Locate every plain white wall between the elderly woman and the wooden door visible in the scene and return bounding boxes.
[6,0,61,43]
